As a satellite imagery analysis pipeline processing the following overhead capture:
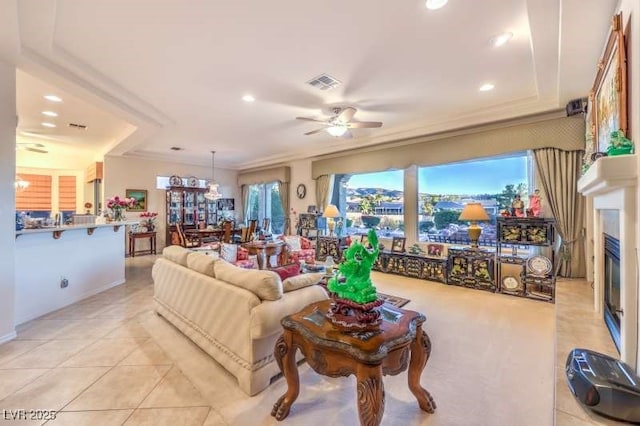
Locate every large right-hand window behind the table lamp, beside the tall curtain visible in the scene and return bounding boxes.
[418,152,535,245]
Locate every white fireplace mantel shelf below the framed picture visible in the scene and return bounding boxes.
[578,154,638,197]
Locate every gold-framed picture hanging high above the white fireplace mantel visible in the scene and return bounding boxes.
[590,13,627,156]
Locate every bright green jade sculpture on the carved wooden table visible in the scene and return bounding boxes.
[327,229,380,305]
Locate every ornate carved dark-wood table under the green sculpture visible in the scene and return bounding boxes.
[271,300,436,425]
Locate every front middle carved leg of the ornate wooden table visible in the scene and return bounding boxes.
[356,364,384,426]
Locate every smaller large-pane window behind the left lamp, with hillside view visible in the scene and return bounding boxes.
[336,170,404,238]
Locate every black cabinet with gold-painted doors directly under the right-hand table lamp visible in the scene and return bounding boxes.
[447,247,497,291]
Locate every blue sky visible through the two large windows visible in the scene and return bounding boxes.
[347,156,527,194]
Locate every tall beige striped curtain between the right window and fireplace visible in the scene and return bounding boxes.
[533,148,586,277]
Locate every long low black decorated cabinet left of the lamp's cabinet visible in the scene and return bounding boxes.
[374,250,447,283]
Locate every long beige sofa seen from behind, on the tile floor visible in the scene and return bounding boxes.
[152,246,327,395]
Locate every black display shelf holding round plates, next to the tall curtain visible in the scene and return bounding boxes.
[497,217,555,302]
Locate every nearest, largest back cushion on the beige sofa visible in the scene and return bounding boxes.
[214,261,283,300]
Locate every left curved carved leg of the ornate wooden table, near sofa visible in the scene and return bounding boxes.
[271,330,300,420]
